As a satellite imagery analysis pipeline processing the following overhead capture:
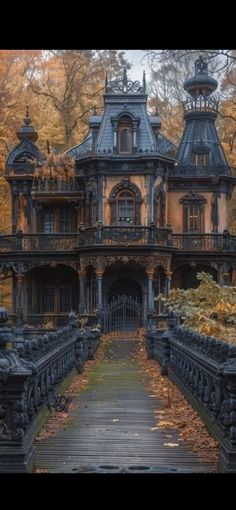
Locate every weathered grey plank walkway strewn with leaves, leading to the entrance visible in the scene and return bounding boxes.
[36,340,215,473]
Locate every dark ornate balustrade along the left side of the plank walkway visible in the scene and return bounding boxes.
[0,322,100,473]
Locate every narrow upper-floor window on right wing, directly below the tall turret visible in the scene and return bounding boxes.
[180,192,206,234]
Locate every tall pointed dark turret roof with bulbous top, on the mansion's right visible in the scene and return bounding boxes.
[175,56,228,171]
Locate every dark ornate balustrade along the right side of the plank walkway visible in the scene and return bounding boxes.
[147,324,236,473]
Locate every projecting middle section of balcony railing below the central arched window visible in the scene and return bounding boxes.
[79,226,172,246]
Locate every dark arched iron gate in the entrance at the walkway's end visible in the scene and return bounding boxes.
[103,295,142,333]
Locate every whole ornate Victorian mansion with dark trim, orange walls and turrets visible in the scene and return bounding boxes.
[0,57,236,329]
